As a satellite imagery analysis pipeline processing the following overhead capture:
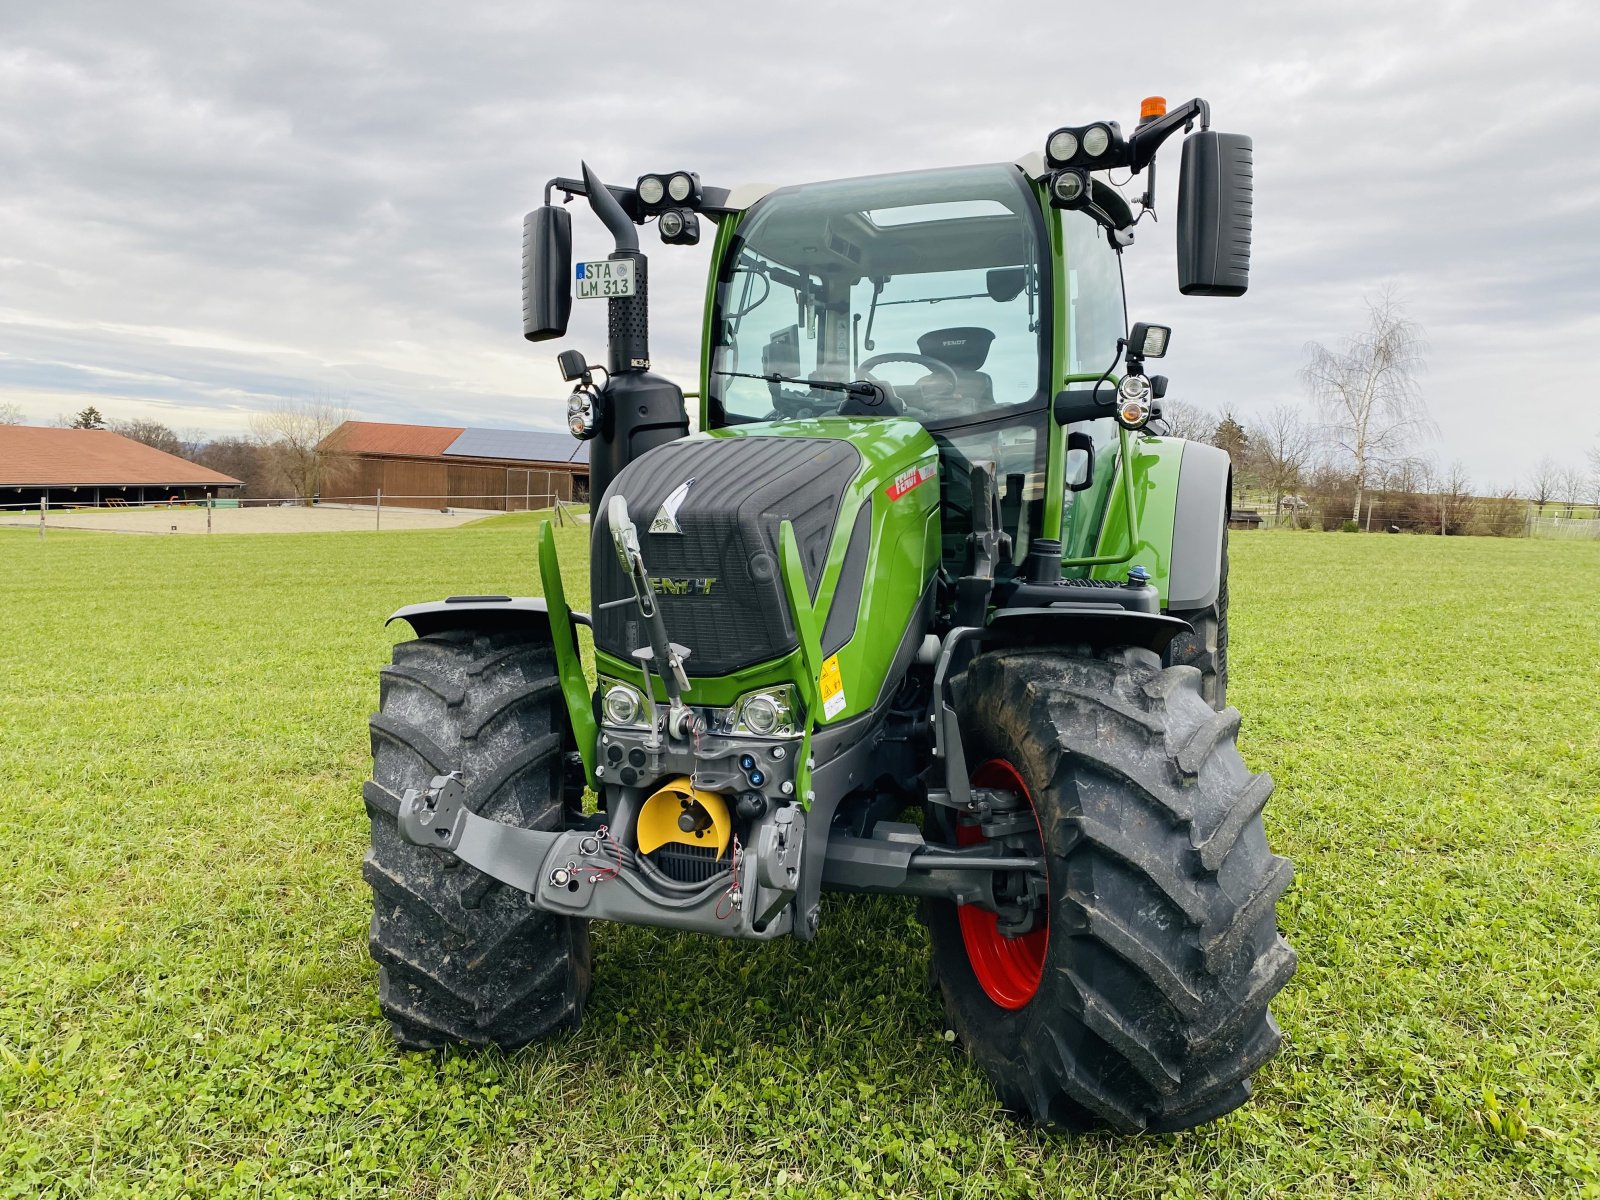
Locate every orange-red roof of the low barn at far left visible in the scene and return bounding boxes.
[0,426,240,488]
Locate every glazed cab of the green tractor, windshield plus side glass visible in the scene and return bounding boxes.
[702,163,1123,574]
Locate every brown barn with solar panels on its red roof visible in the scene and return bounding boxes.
[317,421,589,512]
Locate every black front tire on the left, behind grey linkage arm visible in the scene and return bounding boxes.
[362,630,589,1050]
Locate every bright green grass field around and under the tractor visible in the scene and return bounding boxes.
[0,522,1600,1200]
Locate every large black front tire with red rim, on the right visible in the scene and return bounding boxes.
[928,650,1296,1131]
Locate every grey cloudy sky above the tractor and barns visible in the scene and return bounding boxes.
[0,0,1600,486]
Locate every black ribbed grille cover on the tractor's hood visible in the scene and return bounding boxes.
[590,437,861,677]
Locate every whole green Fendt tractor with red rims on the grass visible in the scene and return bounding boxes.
[365,99,1294,1131]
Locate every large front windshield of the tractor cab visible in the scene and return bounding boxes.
[707,165,1050,429]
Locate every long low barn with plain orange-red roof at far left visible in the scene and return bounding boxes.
[0,426,242,509]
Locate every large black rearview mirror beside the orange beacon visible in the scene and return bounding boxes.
[1178,130,1254,296]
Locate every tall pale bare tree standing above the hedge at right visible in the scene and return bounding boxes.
[1301,291,1430,522]
